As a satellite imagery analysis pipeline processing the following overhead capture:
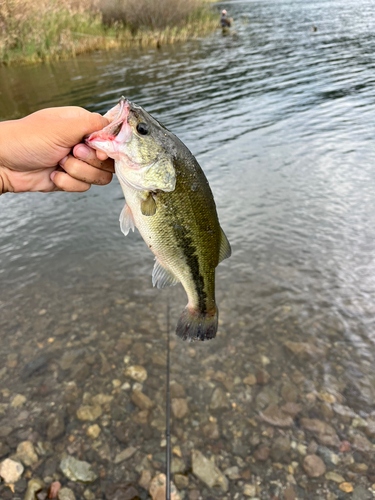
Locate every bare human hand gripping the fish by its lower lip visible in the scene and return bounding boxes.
[0,106,114,194]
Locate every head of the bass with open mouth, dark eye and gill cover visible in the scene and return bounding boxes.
[85,97,176,191]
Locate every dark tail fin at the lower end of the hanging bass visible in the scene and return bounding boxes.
[176,306,218,342]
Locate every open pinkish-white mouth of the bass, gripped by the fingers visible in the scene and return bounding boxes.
[84,97,132,152]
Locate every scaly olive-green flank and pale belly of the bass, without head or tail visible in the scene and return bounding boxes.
[124,156,221,312]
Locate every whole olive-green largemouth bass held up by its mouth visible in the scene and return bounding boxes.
[85,97,231,342]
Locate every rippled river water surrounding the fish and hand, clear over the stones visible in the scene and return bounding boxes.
[0,0,375,500]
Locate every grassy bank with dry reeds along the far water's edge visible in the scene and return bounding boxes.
[0,0,218,64]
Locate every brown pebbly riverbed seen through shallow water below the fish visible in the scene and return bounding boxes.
[0,280,375,500]
